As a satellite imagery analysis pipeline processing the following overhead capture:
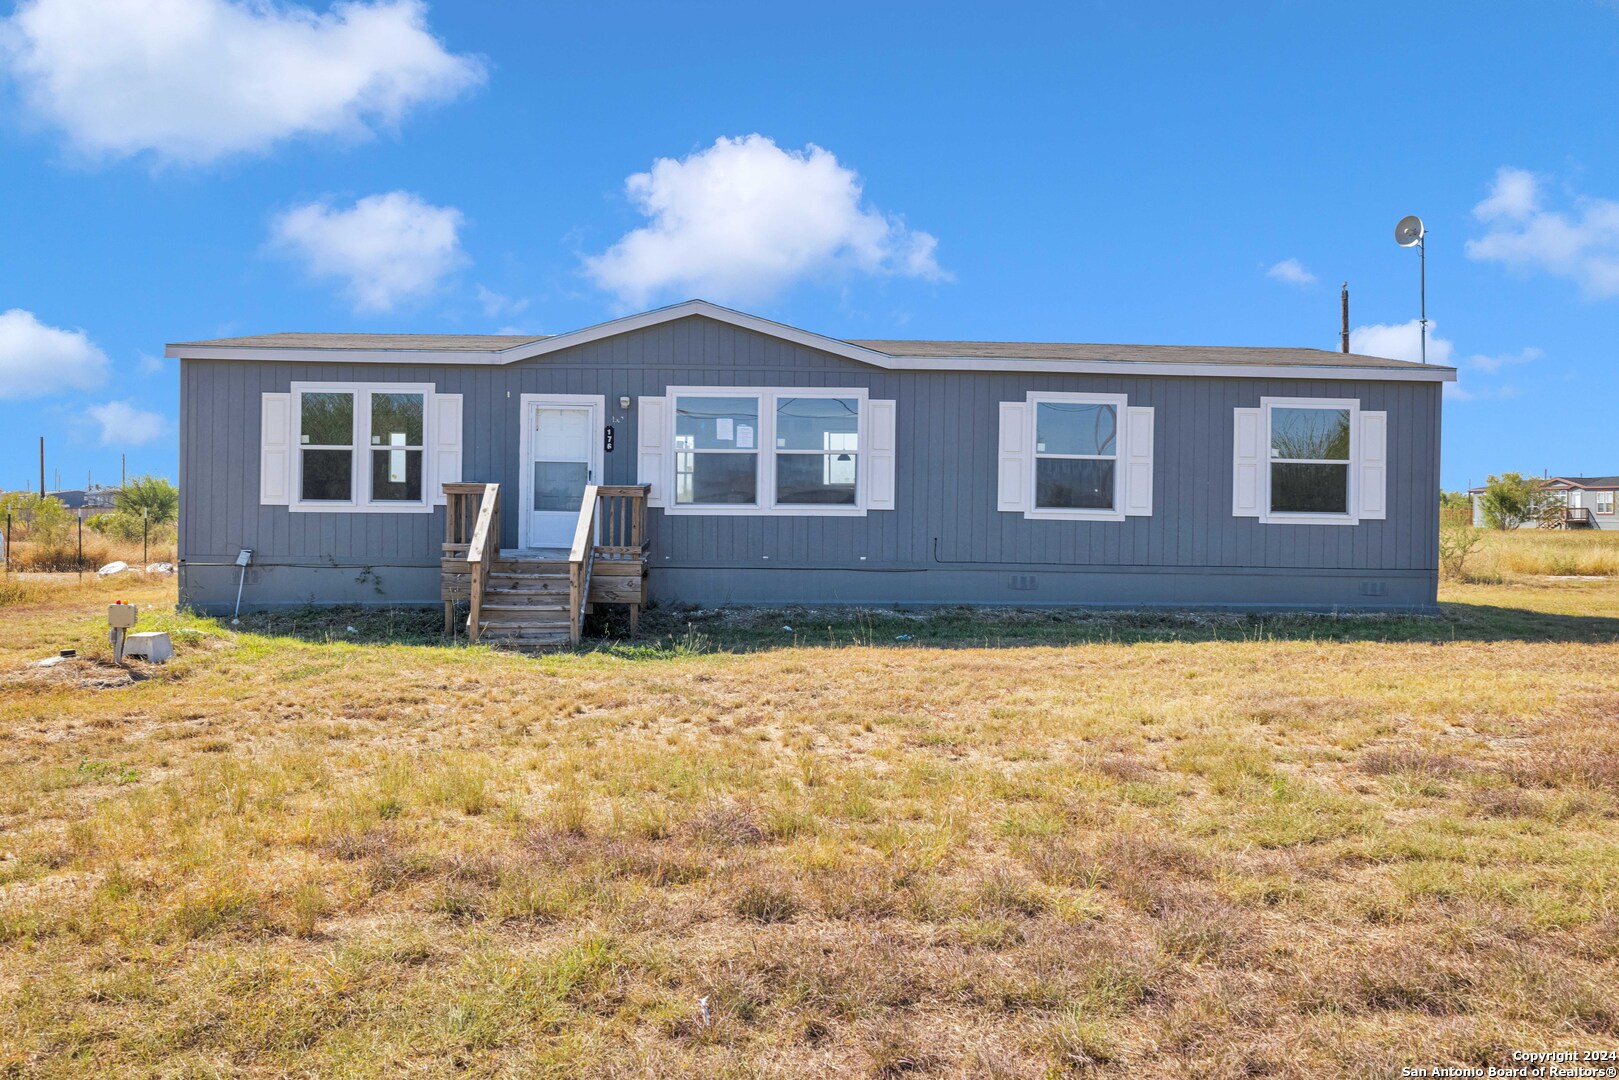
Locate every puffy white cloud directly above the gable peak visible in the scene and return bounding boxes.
[584,134,949,306]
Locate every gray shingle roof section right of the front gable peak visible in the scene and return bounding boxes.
[850,340,1434,368]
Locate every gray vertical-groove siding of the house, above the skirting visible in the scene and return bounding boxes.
[180,317,1439,606]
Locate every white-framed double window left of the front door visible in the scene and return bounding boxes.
[291,384,432,510]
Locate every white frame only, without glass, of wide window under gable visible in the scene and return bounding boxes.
[662,385,871,518]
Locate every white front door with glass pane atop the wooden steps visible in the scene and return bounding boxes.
[521,395,601,547]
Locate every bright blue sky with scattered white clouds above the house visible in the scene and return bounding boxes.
[0,0,1619,487]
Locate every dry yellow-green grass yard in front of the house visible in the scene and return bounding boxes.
[0,536,1619,1077]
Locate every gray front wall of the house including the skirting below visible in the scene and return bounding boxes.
[180,317,1439,610]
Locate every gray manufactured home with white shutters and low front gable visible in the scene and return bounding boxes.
[168,301,1455,636]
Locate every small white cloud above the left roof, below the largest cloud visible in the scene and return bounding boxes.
[270,191,468,311]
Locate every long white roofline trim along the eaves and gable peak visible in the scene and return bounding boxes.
[164,300,1455,382]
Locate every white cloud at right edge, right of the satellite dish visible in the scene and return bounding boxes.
[1467,168,1619,300]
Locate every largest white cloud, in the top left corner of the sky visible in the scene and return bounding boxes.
[0,0,484,164]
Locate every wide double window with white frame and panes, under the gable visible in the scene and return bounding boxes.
[661,387,892,515]
